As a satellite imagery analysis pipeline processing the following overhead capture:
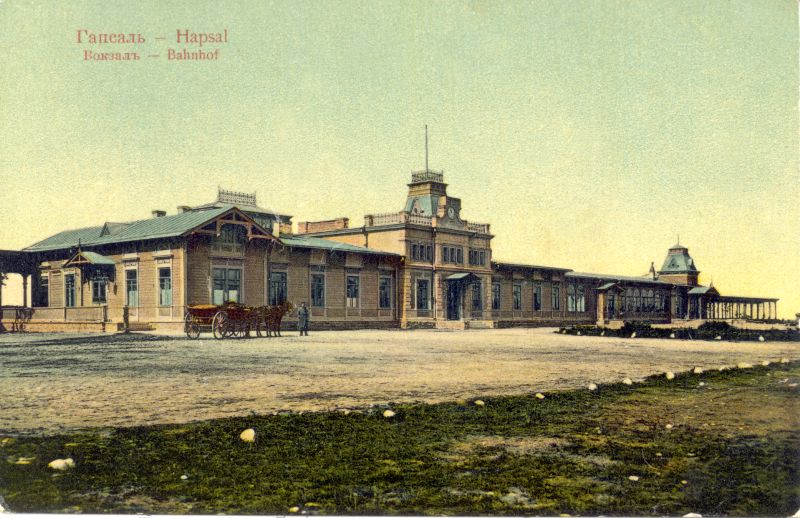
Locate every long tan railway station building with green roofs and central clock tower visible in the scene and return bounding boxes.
[0,169,777,332]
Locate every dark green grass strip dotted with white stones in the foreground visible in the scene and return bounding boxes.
[0,363,800,516]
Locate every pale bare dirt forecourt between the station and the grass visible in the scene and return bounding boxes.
[0,329,800,434]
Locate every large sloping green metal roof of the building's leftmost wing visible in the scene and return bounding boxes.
[23,206,231,252]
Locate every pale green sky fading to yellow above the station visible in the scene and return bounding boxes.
[0,0,800,315]
